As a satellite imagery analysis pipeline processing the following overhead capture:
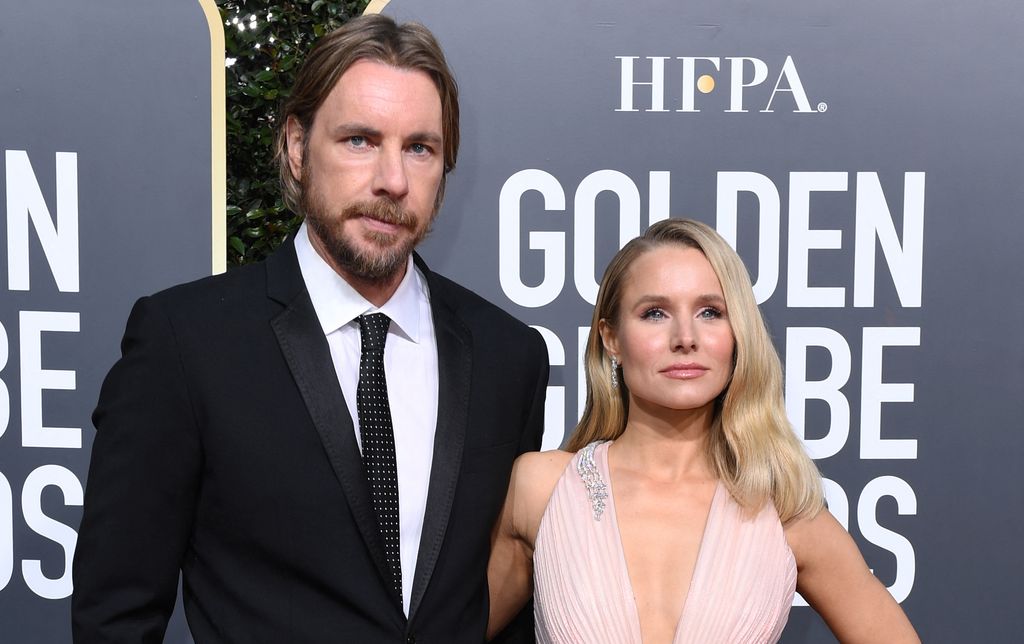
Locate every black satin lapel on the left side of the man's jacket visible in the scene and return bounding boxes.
[267,242,398,600]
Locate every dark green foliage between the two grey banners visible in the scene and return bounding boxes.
[217,0,368,266]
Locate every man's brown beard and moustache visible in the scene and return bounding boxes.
[302,172,437,283]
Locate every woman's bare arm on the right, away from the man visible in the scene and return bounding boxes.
[785,511,921,644]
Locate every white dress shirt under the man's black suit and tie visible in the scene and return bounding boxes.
[295,222,437,615]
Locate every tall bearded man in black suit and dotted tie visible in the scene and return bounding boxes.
[72,16,548,644]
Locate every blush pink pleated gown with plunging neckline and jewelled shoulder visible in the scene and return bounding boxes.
[534,442,797,644]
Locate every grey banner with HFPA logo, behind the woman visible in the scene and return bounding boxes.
[384,0,1024,643]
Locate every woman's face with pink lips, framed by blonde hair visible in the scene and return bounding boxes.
[601,244,735,411]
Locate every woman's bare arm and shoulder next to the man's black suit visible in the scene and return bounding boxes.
[487,452,572,640]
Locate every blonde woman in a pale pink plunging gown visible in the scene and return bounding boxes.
[488,219,919,644]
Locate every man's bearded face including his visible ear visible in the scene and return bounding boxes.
[288,60,444,283]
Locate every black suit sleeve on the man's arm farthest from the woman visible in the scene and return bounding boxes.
[72,298,202,644]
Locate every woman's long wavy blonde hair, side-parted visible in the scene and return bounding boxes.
[566,219,824,522]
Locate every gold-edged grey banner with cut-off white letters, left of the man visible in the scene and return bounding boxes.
[0,0,225,644]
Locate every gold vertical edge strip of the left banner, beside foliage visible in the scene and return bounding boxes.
[199,0,227,274]
